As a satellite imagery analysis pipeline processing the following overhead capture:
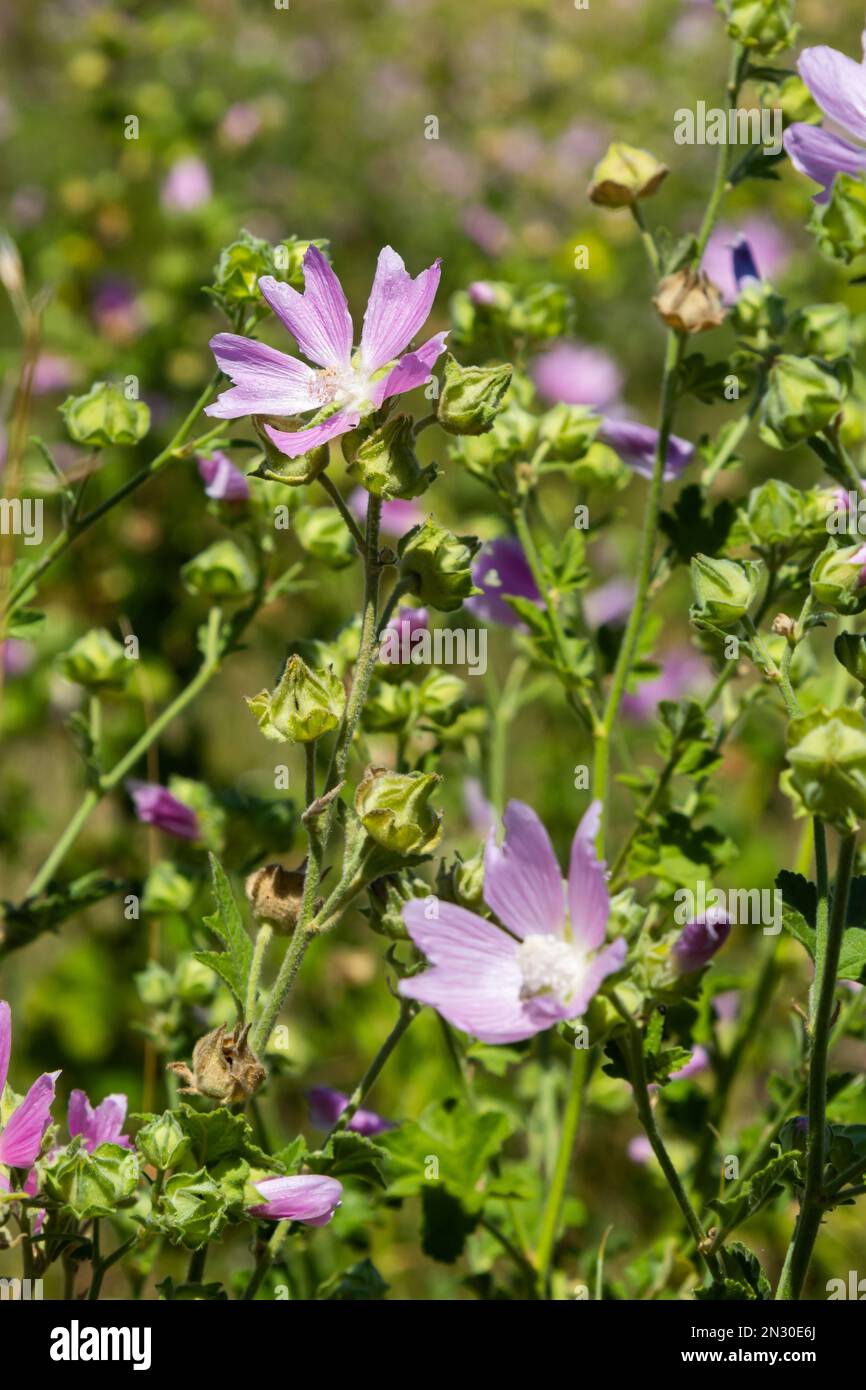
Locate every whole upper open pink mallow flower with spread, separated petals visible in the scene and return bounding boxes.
[207,246,448,459]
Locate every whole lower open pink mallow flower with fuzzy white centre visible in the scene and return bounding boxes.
[399,801,626,1043]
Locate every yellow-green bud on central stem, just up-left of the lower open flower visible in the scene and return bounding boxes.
[354,767,442,855]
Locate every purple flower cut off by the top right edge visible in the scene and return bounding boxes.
[783,31,866,203]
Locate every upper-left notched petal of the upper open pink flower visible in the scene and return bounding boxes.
[259,246,354,367]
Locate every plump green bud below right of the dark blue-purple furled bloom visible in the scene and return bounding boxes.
[760,353,847,449]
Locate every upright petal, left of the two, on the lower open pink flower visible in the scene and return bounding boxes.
[484,801,566,938]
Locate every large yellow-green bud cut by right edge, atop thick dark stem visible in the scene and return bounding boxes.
[781,709,866,833]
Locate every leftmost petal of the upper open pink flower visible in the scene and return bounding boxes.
[204,334,318,420]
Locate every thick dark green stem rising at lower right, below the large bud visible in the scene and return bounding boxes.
[776,834,856,1301]
